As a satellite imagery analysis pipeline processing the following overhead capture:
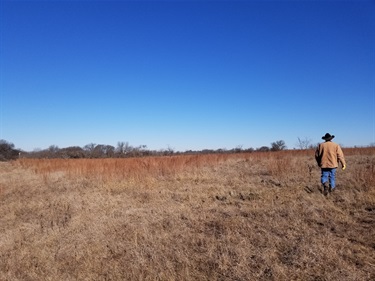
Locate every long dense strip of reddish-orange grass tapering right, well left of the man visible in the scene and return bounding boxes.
[17,153,254,182]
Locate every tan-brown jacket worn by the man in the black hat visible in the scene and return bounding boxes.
[315,141,346,168]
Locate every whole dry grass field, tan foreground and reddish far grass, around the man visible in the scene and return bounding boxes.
[0,148,375,281]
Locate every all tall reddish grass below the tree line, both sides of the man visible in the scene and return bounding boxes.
[16,147,375,186]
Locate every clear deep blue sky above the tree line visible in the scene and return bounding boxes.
[0,0,375,151]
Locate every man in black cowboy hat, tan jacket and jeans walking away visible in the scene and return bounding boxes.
[315,133,346,196]
